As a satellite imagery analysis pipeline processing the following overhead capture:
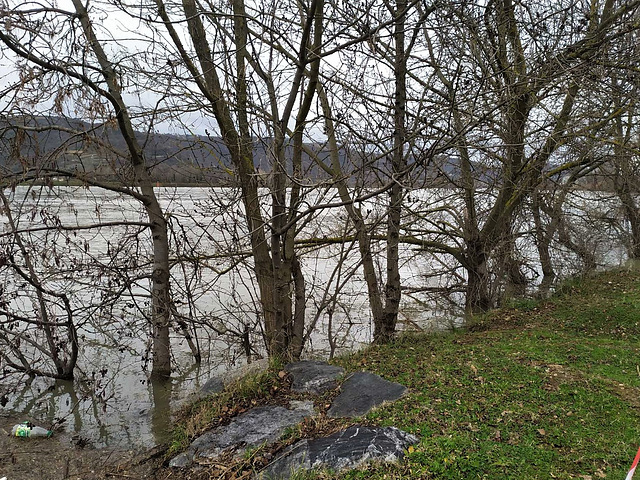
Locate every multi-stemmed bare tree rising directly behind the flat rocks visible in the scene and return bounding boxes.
[149,0,324,359]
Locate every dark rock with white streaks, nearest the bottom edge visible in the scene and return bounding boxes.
[259,425,418,480]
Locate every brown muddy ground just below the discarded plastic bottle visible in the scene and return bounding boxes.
[0,416,164,480]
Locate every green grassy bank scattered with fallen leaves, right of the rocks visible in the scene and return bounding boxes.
[169,271,640,480]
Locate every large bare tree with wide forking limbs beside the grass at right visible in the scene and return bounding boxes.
[410,0,637,312]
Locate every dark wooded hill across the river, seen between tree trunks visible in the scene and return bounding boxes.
[0,116,480,188]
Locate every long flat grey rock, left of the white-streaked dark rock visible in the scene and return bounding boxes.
[169,401,314,467]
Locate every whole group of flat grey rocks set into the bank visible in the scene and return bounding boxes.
[176,361,418,479]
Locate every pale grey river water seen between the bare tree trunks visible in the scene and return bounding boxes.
[0,187,624,448]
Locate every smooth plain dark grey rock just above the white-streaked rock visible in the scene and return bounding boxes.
[327,372,407,418]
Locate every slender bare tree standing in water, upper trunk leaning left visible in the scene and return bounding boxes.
[0,2,171,375]
